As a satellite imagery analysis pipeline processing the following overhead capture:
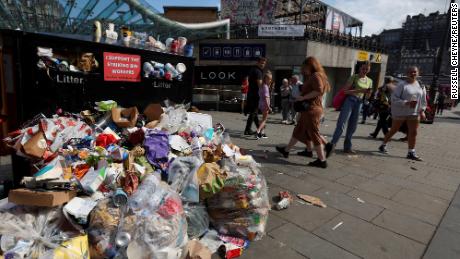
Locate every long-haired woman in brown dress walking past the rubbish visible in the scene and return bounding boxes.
[276,57,330,168]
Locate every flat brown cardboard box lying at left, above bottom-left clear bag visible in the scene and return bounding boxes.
[8,189,77,207]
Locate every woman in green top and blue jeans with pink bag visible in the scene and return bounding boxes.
[326,62,372,156]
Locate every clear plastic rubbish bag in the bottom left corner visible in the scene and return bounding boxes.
[0,206,83,259]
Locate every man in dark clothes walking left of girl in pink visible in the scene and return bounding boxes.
[244,57,267,135]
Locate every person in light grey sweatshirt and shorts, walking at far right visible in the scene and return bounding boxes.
[379,66,427,161]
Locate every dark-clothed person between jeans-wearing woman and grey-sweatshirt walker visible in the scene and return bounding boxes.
[369,76,395,138]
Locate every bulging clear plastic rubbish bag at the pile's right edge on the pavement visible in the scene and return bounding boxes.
[207,160,270,243]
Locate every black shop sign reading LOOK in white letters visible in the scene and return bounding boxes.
[195,66,251,85]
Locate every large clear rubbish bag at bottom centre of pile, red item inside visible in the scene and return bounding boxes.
[88,175,188,259]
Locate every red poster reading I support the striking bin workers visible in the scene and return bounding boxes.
[104,52,141,82]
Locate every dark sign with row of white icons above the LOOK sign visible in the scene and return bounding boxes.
[200,43,265,60]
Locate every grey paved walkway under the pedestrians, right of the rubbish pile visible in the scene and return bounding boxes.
[207,106,460,259]
